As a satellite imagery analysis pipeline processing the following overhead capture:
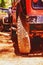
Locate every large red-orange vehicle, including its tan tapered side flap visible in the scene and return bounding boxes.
[13,0,43,53]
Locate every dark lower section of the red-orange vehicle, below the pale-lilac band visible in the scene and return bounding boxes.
[30,24,43,52]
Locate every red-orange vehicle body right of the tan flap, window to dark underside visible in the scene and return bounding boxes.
[26,0,43,51]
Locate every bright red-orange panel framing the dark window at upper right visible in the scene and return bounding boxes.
[26,0,43,15]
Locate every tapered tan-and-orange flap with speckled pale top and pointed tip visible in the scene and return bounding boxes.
[17,18,31,53]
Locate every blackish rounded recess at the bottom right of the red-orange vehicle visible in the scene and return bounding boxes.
[31,36,43,51]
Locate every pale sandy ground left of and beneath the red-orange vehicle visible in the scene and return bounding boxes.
[0,33,43,65]
